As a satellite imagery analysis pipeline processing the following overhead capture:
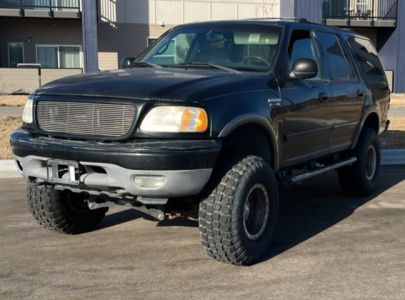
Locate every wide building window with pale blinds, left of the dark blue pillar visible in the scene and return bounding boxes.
[37,45,82,69]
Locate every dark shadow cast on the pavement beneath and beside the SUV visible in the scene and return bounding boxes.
[96,166,405,262]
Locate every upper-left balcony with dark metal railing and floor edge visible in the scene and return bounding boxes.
[0,0,81,19]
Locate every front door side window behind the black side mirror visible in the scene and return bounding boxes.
[288,30,322,80]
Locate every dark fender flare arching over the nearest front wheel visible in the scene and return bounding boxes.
[218,114,279,172]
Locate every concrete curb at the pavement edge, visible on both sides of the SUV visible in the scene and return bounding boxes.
[0,149,405,178]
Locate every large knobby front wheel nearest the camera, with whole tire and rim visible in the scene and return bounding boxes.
[199,156,278,265]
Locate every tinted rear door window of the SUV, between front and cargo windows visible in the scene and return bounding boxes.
[316,32,350,80]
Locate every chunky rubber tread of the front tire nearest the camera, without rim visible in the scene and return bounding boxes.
[199,156,278,265]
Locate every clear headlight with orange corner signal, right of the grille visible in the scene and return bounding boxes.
[141,106,208,132]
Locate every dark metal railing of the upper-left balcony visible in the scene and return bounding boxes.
[0,0,80,12]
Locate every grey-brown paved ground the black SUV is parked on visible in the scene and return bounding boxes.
[0,167,405,300]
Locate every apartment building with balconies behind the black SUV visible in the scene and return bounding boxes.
[0,0,405,93]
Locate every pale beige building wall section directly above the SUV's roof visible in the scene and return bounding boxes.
[98,0,285,25]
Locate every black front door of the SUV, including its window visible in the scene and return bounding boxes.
[281,30,332,167]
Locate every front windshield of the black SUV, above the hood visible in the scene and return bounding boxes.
[135,23,282,72]
